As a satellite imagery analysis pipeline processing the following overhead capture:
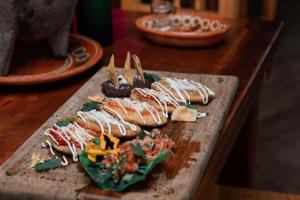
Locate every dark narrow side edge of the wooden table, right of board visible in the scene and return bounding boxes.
[195,19,283,199]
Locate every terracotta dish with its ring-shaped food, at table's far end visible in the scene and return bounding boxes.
[135,12,230,46]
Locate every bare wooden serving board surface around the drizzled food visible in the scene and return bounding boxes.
[0,68,238,200]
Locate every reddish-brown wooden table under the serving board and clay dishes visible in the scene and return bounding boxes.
[0,10,283,199]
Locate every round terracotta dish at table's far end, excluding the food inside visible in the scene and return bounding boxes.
[135,12,230,47]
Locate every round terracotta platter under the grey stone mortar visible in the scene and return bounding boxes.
[0,34,103,85]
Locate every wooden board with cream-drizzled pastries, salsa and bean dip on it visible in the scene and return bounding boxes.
[0,53,238,199]
